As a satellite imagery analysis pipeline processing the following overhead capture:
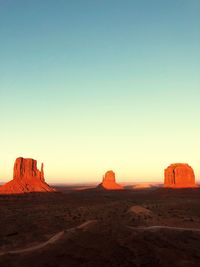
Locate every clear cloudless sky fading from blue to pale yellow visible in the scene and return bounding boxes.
[0,0,200,182]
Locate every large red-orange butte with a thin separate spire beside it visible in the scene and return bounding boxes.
[0,157,55,194]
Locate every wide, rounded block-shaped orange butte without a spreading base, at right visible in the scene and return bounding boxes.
[164,163,196,188]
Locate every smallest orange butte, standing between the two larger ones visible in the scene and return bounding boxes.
[99,171,123,190]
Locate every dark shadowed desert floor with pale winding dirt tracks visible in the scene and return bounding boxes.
[0,187,200,267]
